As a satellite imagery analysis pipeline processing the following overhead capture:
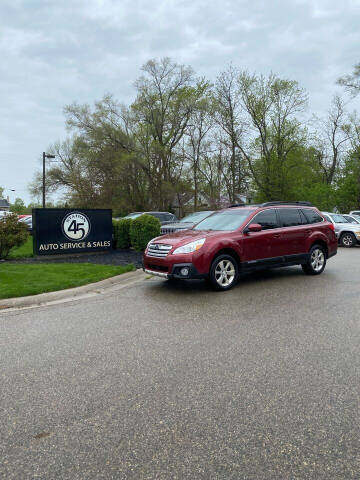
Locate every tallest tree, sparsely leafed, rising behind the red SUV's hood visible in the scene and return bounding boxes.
[131,58,207,209]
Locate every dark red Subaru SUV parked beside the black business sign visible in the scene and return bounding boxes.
[144,202,337,290]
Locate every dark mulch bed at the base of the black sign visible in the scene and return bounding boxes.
[6,249,143,268]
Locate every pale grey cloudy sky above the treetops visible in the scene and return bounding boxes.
[0,0,360,201]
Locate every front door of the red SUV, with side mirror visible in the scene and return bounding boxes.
[242,208,281,266]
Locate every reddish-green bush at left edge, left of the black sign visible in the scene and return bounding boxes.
[0,214,29,258]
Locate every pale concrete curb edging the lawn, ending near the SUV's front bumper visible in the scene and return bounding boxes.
[0,270,145,312]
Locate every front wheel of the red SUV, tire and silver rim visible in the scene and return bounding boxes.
[209,254,239,291]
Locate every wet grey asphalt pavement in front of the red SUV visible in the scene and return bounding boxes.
[0,248,360,480]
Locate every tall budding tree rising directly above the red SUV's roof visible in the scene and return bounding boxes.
[239,72,307,200]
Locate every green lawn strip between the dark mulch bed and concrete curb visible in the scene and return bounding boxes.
[0,263,134,298]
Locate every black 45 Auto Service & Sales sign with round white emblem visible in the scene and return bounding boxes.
[32,208,112,255]
